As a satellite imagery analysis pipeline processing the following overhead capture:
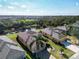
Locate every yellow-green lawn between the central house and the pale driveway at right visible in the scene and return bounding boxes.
[47,40,74,59]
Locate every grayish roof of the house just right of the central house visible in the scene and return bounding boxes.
[43,28,64,40]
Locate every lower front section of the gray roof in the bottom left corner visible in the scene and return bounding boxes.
[0,44,25,59]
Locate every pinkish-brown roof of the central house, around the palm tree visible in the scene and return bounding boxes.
[18,31,45,53]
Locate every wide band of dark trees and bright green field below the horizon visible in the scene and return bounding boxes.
[0,16,79,34]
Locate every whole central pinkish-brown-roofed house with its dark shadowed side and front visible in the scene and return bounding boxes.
[17,31,50,59]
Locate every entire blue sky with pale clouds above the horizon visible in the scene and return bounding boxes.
[0,0,79,15]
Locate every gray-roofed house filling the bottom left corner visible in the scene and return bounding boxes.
[0,36,25,59]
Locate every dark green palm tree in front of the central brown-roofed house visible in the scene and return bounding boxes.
[30,34,46,59]
